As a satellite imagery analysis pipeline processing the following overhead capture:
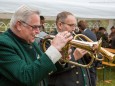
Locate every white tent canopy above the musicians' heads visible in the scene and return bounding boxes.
[0,0,115,19]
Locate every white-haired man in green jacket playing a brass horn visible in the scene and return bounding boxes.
[0,6,73,86]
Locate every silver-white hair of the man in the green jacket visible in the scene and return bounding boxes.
[10,5,40,29]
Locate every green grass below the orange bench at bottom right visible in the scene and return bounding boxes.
[97,67,115,86]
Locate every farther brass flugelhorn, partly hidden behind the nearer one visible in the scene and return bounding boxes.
[74,34,115,62]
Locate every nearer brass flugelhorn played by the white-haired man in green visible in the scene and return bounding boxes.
[42,35,102,68]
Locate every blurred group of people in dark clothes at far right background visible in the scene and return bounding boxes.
[92,26,115,49]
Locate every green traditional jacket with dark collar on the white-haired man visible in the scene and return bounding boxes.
[0,29,56,86]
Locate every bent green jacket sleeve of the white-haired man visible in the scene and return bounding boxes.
[0,41,56,86]
